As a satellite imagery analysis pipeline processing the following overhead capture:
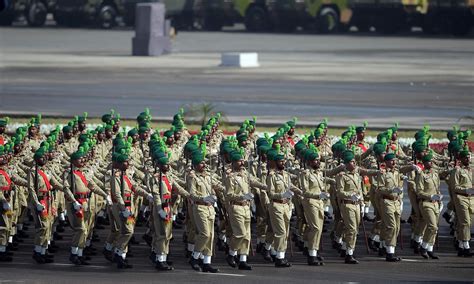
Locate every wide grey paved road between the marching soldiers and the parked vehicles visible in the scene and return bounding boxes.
[0,27,474,129]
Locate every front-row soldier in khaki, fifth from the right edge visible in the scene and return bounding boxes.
[299,149,344,265]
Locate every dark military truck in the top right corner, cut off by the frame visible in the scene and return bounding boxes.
[349,0,474,35]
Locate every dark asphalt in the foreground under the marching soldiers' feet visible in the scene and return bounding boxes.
[0,185,474,283]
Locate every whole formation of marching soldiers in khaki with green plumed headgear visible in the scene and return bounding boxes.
[0,110,474,273]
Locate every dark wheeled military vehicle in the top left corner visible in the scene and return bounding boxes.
[0,0,56,27]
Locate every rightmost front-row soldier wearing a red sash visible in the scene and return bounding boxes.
[152,151,189,271]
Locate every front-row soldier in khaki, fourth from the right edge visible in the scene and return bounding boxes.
[336,150,378,264]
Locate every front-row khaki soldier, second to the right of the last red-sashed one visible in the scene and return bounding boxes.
[225,151,266,270]
